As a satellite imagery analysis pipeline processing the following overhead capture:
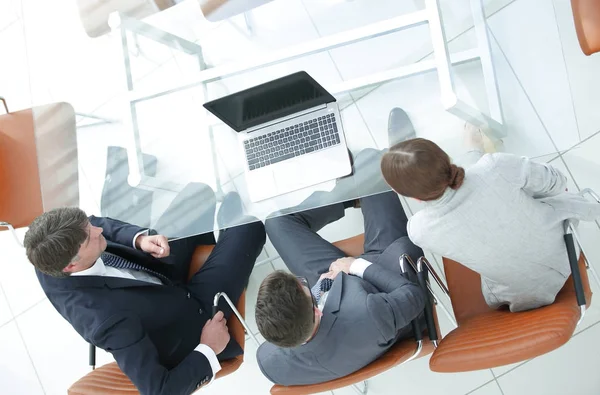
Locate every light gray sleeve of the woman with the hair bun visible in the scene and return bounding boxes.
[492,154,567,199]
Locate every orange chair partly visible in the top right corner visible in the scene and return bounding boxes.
[571,0,600,56]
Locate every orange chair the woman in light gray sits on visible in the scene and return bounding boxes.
[429,210,594,372]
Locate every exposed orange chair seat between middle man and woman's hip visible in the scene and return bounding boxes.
[443,258,492,325]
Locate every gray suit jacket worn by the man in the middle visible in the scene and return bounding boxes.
[257,264,425,385]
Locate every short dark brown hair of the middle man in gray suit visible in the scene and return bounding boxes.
[255,270,314,347]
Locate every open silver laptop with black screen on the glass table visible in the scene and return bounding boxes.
[204,71,352,202]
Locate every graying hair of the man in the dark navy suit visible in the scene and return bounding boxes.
[24,207,88,277]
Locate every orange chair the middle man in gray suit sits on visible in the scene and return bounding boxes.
[271,234,439,395]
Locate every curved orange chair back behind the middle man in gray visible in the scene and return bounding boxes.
[271,336,433,395]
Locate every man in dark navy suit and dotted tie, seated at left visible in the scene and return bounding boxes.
[25,190,265,395]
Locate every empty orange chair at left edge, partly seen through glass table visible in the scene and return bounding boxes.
[0,97,79,243]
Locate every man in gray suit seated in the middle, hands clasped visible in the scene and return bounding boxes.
[256,108,425,385]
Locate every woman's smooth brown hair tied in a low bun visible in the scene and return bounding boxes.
[381,138,465,201]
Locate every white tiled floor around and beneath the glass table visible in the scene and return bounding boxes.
[0,0,600,395]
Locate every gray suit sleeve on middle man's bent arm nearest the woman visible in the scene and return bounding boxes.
[363,264,425,341]
